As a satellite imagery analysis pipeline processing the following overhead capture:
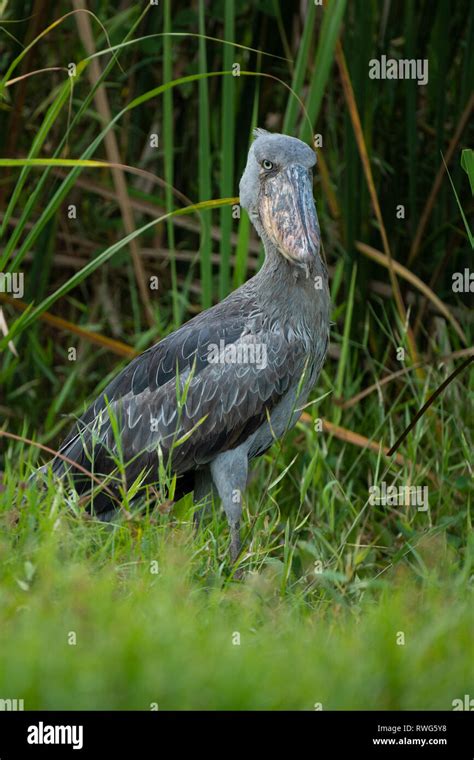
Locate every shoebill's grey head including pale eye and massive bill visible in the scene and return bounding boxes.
[240,129,320,268]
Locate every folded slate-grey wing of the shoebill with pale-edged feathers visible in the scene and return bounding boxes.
[52,308,305,480]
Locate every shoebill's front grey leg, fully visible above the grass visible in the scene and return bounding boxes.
[211,448,248,577]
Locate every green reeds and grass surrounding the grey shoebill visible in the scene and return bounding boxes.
[0,0,474,709]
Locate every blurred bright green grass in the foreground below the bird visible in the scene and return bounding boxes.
[0,478,473,710]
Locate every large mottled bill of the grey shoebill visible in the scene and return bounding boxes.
[259,164,320,268]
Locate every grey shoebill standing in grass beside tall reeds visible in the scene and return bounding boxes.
[37,129,330,563]
